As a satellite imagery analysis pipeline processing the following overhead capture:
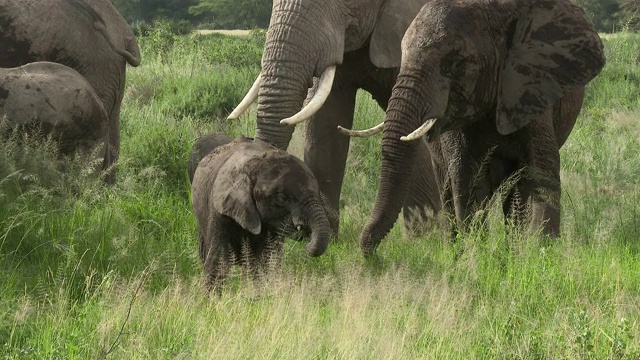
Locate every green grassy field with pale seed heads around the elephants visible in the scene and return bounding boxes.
[0,30,640,359]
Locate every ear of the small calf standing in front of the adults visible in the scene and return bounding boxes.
[212,156,262,235]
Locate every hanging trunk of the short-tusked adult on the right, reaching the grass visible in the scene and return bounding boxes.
[360,78,432,256]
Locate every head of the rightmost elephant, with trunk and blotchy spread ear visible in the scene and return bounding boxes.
[360,0,605,254]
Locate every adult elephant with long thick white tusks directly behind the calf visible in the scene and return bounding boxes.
[230,0,428,231]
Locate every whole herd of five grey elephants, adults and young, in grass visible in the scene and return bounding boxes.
[0,0,605,285]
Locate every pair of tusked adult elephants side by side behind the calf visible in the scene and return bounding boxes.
[230,0,605,272]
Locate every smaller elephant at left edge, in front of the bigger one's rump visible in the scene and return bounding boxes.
[0,62,109,177]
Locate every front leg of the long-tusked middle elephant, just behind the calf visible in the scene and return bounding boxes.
[304,85,357,234]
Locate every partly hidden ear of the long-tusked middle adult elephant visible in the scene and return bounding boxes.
[369,0,426,68]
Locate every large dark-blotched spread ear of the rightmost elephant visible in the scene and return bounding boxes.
[496,0,605,135]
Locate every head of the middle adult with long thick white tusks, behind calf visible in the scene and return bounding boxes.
[230,0,426,149]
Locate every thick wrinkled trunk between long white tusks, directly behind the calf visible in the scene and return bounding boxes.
[255,1,344,150]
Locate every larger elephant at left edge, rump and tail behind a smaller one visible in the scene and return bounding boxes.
[0,0,140,182]
